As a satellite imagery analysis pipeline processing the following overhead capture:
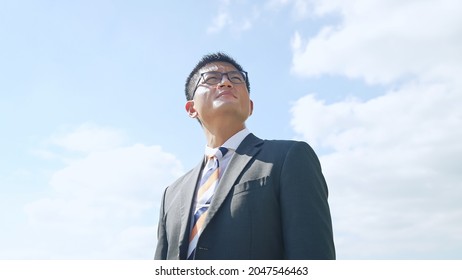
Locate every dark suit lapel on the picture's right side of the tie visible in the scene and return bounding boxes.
[204,134,263,231]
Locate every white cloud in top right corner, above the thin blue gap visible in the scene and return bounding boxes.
[293,0,462,84]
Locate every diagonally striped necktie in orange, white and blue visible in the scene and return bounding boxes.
[188,147,228,260]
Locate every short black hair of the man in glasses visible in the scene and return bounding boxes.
[184,52,250,100]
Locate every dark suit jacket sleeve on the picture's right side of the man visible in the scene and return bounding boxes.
[280,142,335,260]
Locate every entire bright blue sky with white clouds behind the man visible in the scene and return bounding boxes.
[0,0,462,259]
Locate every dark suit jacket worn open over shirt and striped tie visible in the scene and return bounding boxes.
[154,134,335,260]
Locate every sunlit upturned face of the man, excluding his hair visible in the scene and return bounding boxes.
[186,62,253,125]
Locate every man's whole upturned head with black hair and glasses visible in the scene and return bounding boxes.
[185,53,253,130]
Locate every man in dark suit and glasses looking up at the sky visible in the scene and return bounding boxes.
[154,53,335,260]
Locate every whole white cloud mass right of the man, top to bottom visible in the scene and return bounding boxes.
[292,1,462,259]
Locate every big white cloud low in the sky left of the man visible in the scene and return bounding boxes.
[18,125,183,259]
